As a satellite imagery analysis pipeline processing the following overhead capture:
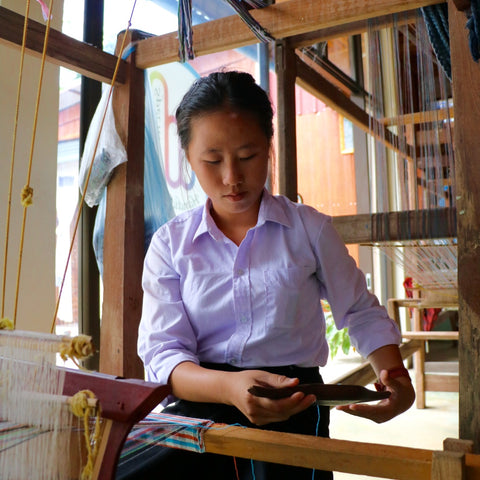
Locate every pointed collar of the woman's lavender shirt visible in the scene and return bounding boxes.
[193,188,292,241]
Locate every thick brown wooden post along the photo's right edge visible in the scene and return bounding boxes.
[448,0,480,453]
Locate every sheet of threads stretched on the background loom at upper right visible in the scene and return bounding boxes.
[367,11,457,290]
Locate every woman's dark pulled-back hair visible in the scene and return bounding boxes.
[175,71,273,150]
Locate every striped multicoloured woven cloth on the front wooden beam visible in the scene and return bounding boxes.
[120,413,213,463]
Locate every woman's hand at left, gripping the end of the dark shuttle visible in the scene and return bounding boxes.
[224,370,316,426]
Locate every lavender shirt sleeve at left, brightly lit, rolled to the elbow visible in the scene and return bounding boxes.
[138,232,198,390]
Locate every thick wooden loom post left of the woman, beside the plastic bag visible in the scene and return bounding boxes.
[100,31,145,378]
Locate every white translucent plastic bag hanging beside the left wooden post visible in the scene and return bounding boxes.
[79,88,127,207]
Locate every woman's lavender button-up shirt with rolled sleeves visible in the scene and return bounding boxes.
[138,190,400,390]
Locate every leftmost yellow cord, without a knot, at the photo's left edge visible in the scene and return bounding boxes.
[0,0,30,317]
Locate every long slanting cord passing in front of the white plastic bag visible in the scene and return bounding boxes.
[50,0,137,333]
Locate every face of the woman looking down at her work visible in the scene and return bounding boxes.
[186,109,270,227]
